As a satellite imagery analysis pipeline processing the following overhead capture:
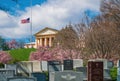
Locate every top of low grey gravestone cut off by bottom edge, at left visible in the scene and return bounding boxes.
[7,77,36,81]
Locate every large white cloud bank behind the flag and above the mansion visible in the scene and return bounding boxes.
[0,0,100,38]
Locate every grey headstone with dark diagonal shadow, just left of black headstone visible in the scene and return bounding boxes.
[48,61,62,72]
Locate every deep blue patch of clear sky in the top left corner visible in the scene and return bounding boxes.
[0,0,47,15]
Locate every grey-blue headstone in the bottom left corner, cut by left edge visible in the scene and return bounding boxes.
[0,69,15,81]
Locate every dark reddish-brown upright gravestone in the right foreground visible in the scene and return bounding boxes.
[87,60,103,81]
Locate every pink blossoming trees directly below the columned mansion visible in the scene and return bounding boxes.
[29,46,82,61]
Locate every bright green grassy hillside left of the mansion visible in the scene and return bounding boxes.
[9,48,36,61]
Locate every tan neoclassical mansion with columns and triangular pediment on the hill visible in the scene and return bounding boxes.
[24,27,58,48]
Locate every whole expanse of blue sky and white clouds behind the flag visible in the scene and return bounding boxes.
[0,0,100,38]
